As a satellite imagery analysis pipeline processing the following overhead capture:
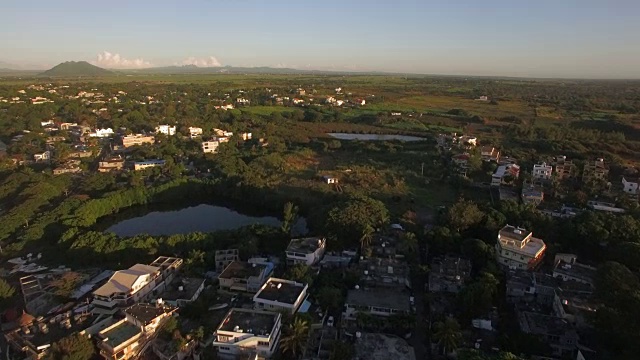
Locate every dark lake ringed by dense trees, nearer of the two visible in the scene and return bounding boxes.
[106,204,308,236]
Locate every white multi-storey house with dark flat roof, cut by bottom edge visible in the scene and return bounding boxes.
[213,309,282,360]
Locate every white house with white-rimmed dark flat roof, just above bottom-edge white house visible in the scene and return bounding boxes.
[253,277,309,314]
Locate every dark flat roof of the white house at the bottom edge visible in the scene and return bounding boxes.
[218,308,281,336]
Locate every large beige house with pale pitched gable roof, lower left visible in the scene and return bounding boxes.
[92,256,182,314]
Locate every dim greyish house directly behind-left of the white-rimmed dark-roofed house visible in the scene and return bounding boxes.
[218,261,274,293]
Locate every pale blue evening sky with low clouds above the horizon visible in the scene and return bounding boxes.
[0,0,640,78]
